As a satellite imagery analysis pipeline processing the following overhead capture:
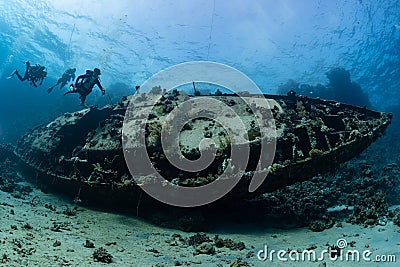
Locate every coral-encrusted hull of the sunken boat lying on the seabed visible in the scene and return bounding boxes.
[14,92,391,205]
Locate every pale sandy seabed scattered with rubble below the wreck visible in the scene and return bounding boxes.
[0,180,400,267]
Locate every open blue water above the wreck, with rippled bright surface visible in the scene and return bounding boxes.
[0,0,400,143]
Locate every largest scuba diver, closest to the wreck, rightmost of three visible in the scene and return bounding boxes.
[64,68,106,107]
